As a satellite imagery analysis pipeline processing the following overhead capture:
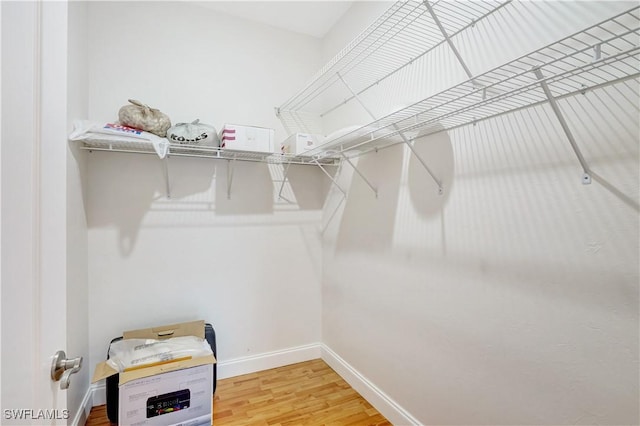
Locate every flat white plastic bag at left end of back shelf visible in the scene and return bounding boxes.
[69,120,169,158]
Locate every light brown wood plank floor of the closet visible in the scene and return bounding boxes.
[86,359,391,426]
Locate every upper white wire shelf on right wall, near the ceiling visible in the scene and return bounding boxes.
[277,0,511,116]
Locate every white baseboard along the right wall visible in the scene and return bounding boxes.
[321,344,422,425]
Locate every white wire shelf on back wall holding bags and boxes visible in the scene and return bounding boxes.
[78,140,338,166]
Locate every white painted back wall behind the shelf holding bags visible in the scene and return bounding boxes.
[84,2,326,382]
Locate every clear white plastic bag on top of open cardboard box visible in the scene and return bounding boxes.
[107,336,213,373]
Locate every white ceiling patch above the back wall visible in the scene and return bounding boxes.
[194,1,353,38]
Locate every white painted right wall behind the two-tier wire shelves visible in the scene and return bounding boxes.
[322,2,640,424]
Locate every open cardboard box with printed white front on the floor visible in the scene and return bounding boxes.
[92,321,216,426]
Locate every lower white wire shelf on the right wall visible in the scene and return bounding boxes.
[307,6,640,157]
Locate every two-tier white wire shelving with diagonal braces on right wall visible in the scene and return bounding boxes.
[276,0,640,196]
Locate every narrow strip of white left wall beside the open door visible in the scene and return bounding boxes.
[65,2,92,424]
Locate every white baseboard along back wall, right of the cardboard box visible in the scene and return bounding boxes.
[218,343,320,379]
